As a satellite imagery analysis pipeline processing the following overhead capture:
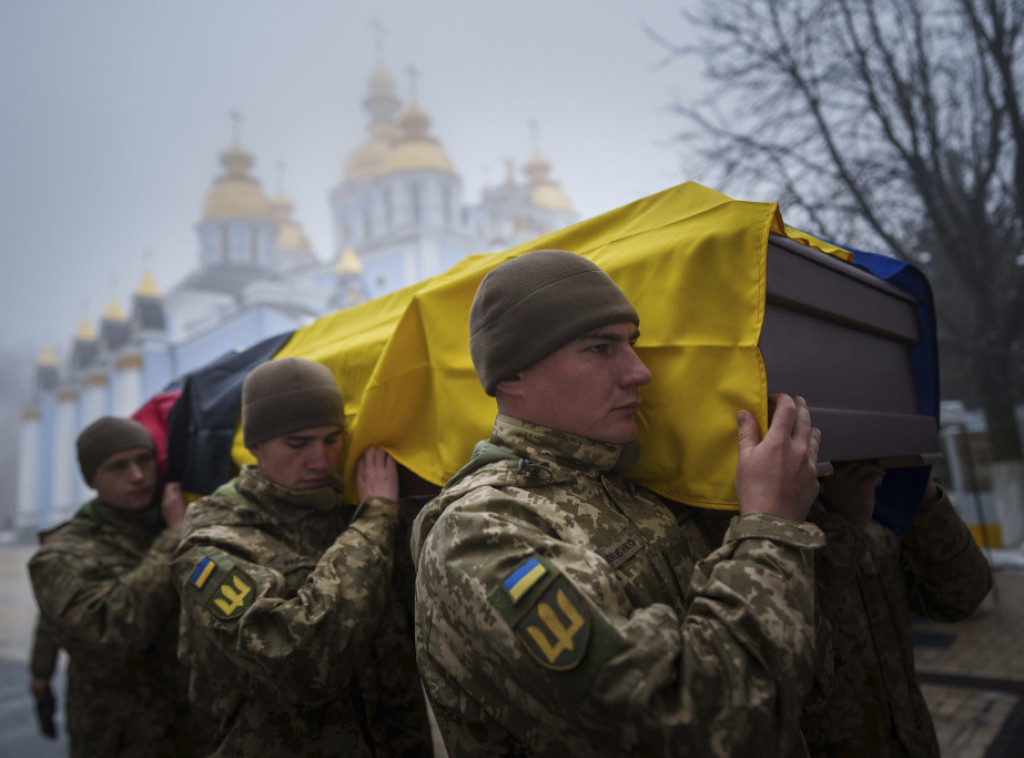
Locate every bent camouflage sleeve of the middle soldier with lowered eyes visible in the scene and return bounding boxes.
[173,498,397,704]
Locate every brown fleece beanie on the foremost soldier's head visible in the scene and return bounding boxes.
[469,250,640,395]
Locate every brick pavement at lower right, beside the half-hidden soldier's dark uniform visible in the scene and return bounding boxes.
[914,571,1024,758]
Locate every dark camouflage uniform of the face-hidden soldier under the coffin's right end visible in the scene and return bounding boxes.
[801,483,992,758]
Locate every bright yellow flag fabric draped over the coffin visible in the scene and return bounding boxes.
[233,183,845,508]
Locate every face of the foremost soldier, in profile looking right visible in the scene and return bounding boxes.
[499,322,650,445]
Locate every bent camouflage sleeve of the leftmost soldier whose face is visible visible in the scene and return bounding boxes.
[29,529,180,660]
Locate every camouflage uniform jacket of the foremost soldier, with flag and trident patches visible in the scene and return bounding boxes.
[413,416,823,758]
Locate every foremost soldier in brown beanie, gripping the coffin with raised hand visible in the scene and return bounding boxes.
[413,250,823,758]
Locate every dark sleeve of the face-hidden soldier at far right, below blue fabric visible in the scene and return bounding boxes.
[900,488,992,622]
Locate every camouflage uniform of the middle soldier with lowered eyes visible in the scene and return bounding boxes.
[173,466,429,758]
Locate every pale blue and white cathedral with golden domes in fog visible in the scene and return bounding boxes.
[15,66,578,532]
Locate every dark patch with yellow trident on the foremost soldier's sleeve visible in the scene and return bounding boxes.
[515,566,591,671]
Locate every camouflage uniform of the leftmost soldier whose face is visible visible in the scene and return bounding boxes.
[29,500,186,758]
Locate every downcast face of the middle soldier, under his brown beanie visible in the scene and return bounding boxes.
[250,426,342,490]
